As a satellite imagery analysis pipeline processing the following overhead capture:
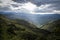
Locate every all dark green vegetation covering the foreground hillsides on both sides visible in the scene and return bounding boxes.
[0,15,60,40]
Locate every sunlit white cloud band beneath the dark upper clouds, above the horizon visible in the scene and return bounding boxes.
[0,0,60,14]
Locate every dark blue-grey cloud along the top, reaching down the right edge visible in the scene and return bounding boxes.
[13,0,60,10]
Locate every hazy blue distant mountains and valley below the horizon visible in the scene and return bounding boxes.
[0,12,60,27]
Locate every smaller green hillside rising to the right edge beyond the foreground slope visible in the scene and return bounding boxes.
[41,19,60,32]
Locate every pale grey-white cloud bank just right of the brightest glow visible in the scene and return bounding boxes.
[35,4,53,13]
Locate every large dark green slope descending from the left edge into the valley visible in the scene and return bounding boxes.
[0,14,49,40]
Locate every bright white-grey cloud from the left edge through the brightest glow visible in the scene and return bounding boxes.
[0,0,36,13]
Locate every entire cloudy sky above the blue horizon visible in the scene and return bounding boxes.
[0,0,60,14]
